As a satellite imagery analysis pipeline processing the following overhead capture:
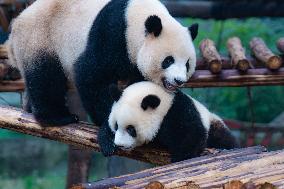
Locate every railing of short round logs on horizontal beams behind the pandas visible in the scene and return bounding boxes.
[0,37,284,91]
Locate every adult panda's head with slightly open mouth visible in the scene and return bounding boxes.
[137,15,198,91]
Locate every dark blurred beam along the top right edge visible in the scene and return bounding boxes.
[163,0,284,19]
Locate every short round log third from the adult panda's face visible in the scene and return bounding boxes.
[250,37,282,70]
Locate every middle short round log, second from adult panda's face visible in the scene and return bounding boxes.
[227,37,250,72]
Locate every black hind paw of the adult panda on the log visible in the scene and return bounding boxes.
[36,114,79,127]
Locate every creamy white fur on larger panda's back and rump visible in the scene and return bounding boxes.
[9,0,110,80]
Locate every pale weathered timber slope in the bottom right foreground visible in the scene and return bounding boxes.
[69,146,284,189]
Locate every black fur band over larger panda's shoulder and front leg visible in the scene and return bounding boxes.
[75,0,143,125]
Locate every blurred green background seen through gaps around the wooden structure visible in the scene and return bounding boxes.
[0,0,284,189]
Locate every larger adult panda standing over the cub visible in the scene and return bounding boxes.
[7,0,198,125]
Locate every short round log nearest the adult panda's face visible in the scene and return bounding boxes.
[200,39,222,74]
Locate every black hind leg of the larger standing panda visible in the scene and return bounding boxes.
[24,52,78,126]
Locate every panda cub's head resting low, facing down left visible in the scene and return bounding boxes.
[108,82,173,150]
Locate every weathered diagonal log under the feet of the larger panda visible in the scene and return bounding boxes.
[0,106,170,165]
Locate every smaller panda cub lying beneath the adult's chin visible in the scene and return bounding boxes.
[98,81,239,162]
